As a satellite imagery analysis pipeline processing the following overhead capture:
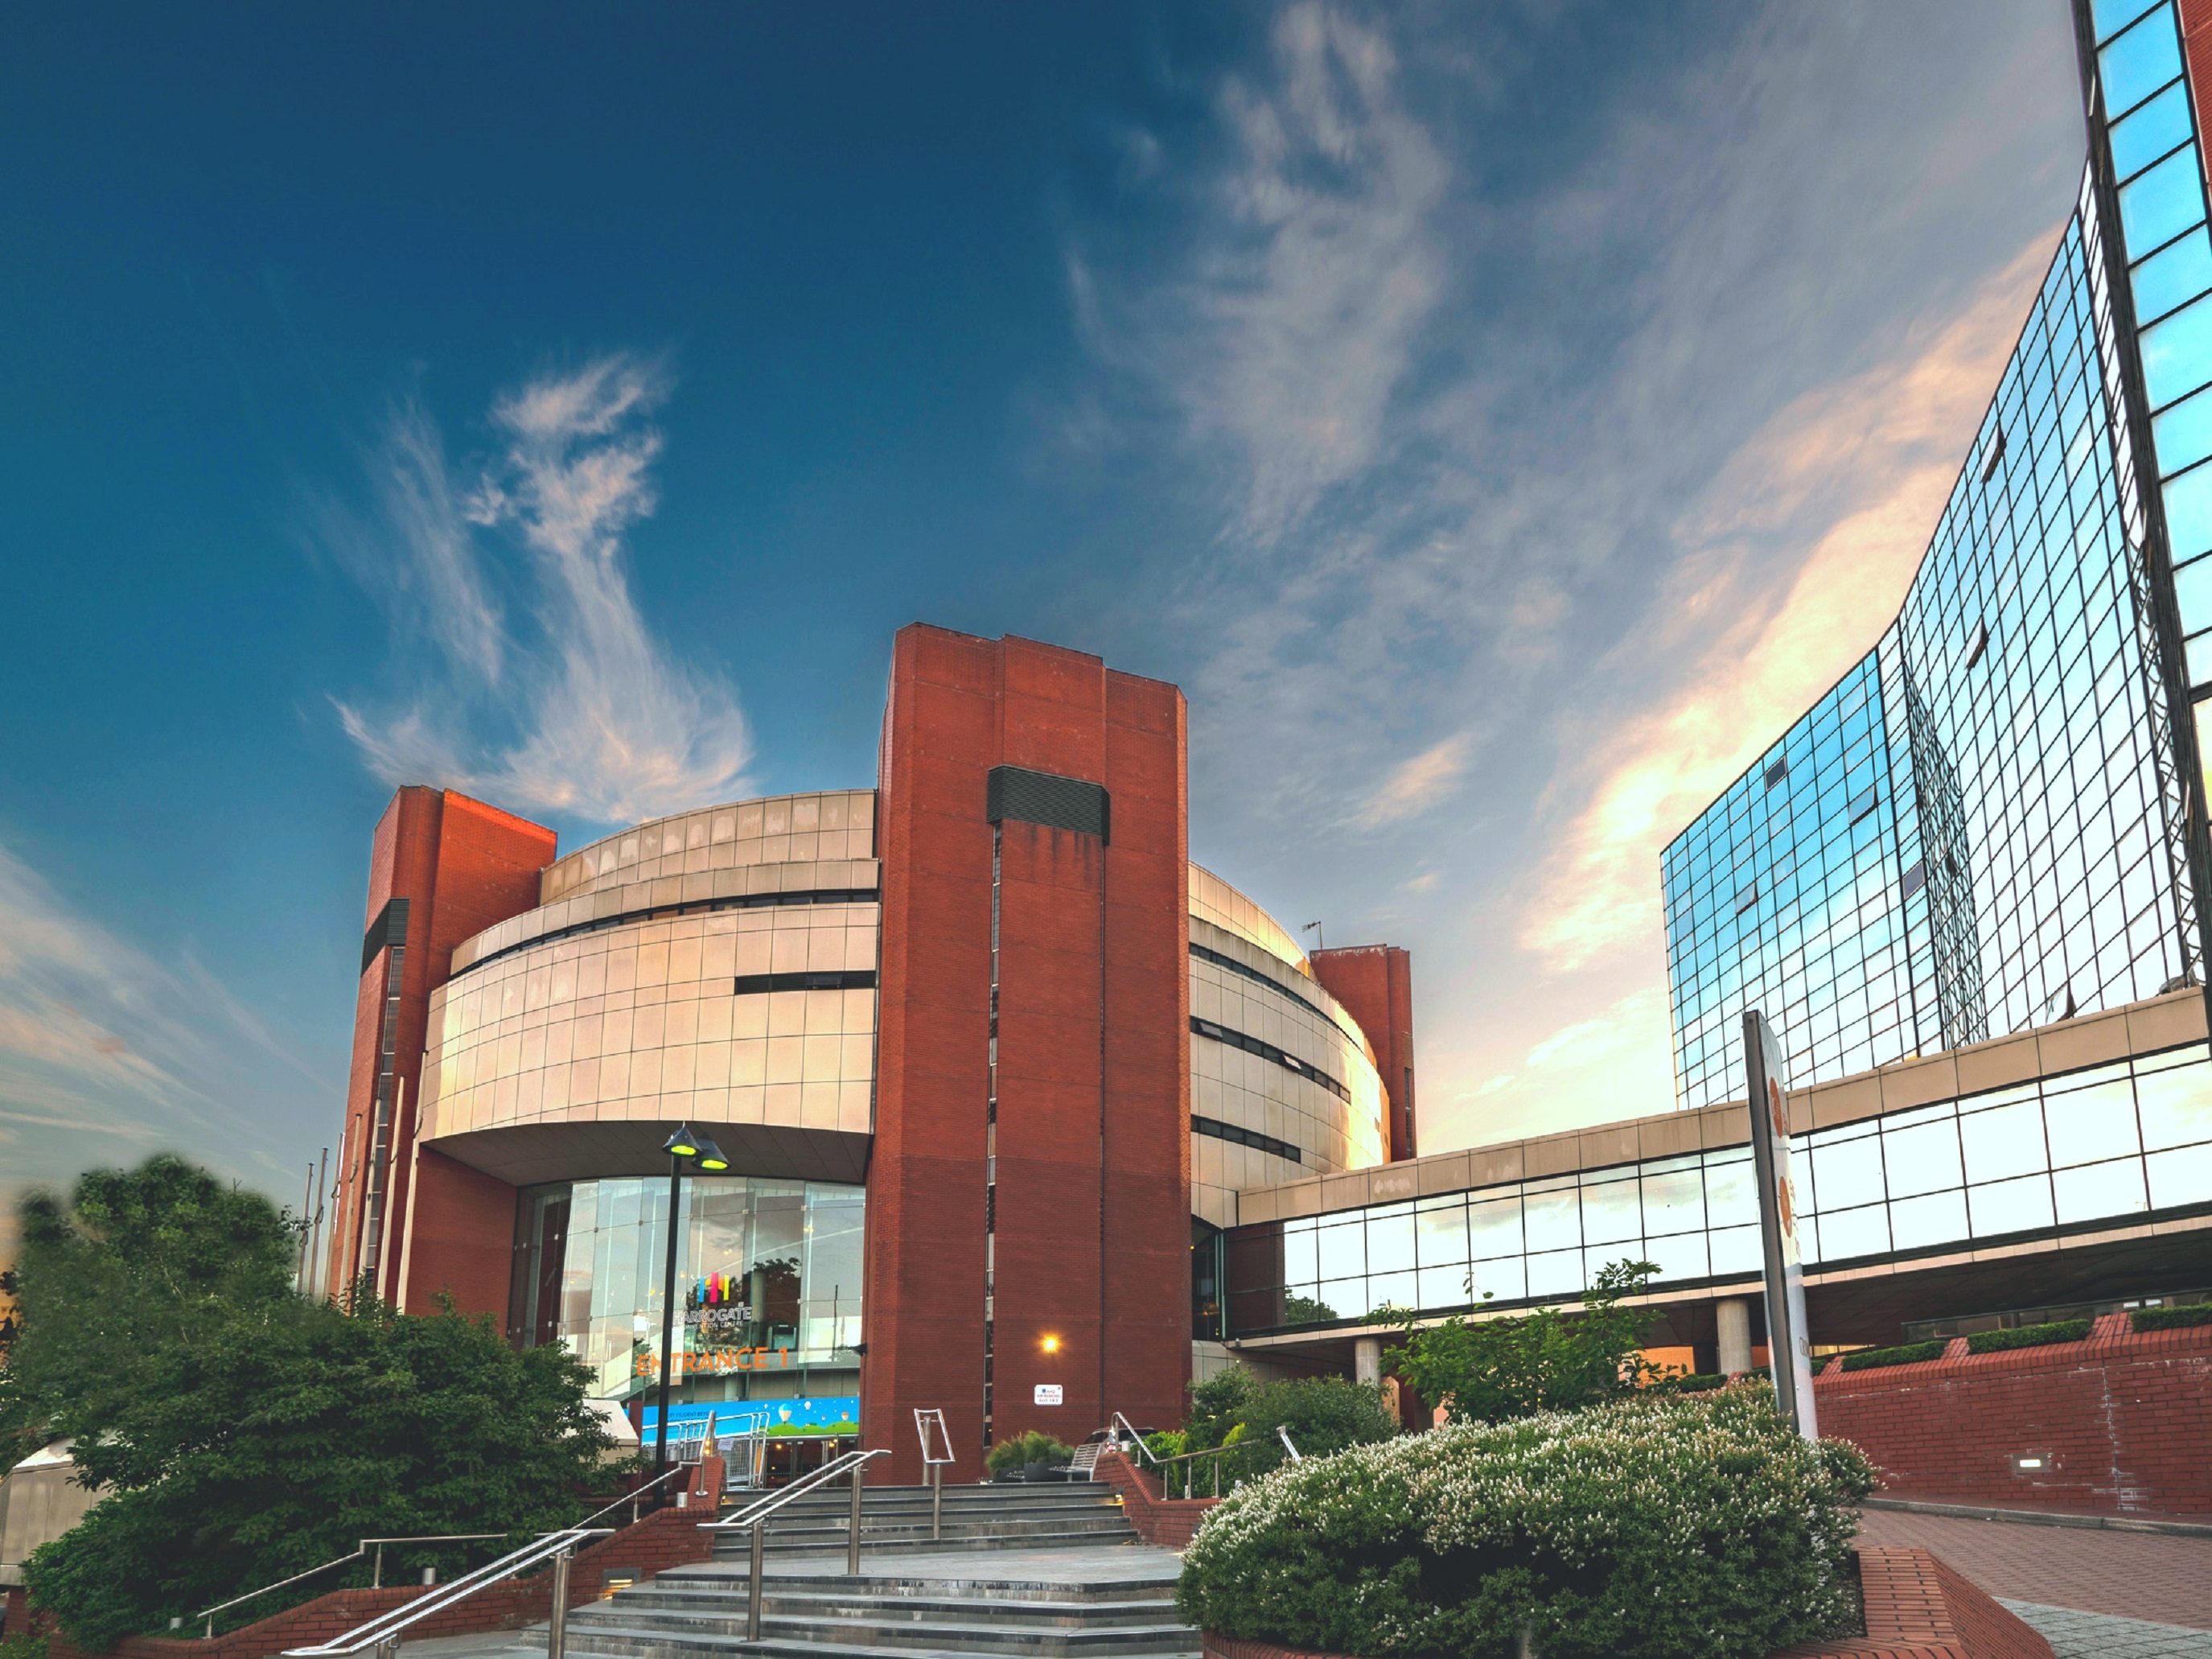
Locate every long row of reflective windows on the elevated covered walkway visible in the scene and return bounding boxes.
[1226,1044,2212,1336]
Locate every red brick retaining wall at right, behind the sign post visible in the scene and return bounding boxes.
[1814,1314,2212,1515]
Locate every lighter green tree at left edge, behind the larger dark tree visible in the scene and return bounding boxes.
[0,1155,298,1462]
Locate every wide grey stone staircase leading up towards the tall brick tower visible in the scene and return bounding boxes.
[569,1484,1199,1659]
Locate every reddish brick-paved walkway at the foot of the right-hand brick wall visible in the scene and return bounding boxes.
[1858,1509,2212,1646]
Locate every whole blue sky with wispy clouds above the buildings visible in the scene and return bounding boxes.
[0,0,2082,1221]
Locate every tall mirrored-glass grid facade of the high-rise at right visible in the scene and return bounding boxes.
[1661,0,2212,1108]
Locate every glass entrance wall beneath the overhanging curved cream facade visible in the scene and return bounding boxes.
[511,1177,865,1398]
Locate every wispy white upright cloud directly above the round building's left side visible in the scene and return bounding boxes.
[339,356,752,823]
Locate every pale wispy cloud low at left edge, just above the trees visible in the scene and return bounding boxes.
[0,847,323,1249]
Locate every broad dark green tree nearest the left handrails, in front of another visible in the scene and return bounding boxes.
[24,1301,613,1650]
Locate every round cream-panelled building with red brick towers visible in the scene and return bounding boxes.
[327,626,1413,1480]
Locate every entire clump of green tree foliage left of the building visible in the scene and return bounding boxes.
[9,1159,613,1650]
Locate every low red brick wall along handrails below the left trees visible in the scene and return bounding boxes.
[47,1458,722,1659]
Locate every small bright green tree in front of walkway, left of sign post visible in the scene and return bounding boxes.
[1380,1261,1659,1451]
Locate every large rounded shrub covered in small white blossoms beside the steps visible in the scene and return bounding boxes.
[1174,1382,1873,1659]
